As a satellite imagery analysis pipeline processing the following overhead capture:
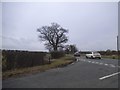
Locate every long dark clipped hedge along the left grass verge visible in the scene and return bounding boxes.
[2,50,48,72]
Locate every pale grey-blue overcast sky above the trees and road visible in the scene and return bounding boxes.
[0,2,118,51]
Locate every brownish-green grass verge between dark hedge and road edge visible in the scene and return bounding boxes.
[2,55,75,79]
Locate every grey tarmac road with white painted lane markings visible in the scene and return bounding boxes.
[2,58,120,88]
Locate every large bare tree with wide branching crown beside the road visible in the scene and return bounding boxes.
[37,23,68,51]
